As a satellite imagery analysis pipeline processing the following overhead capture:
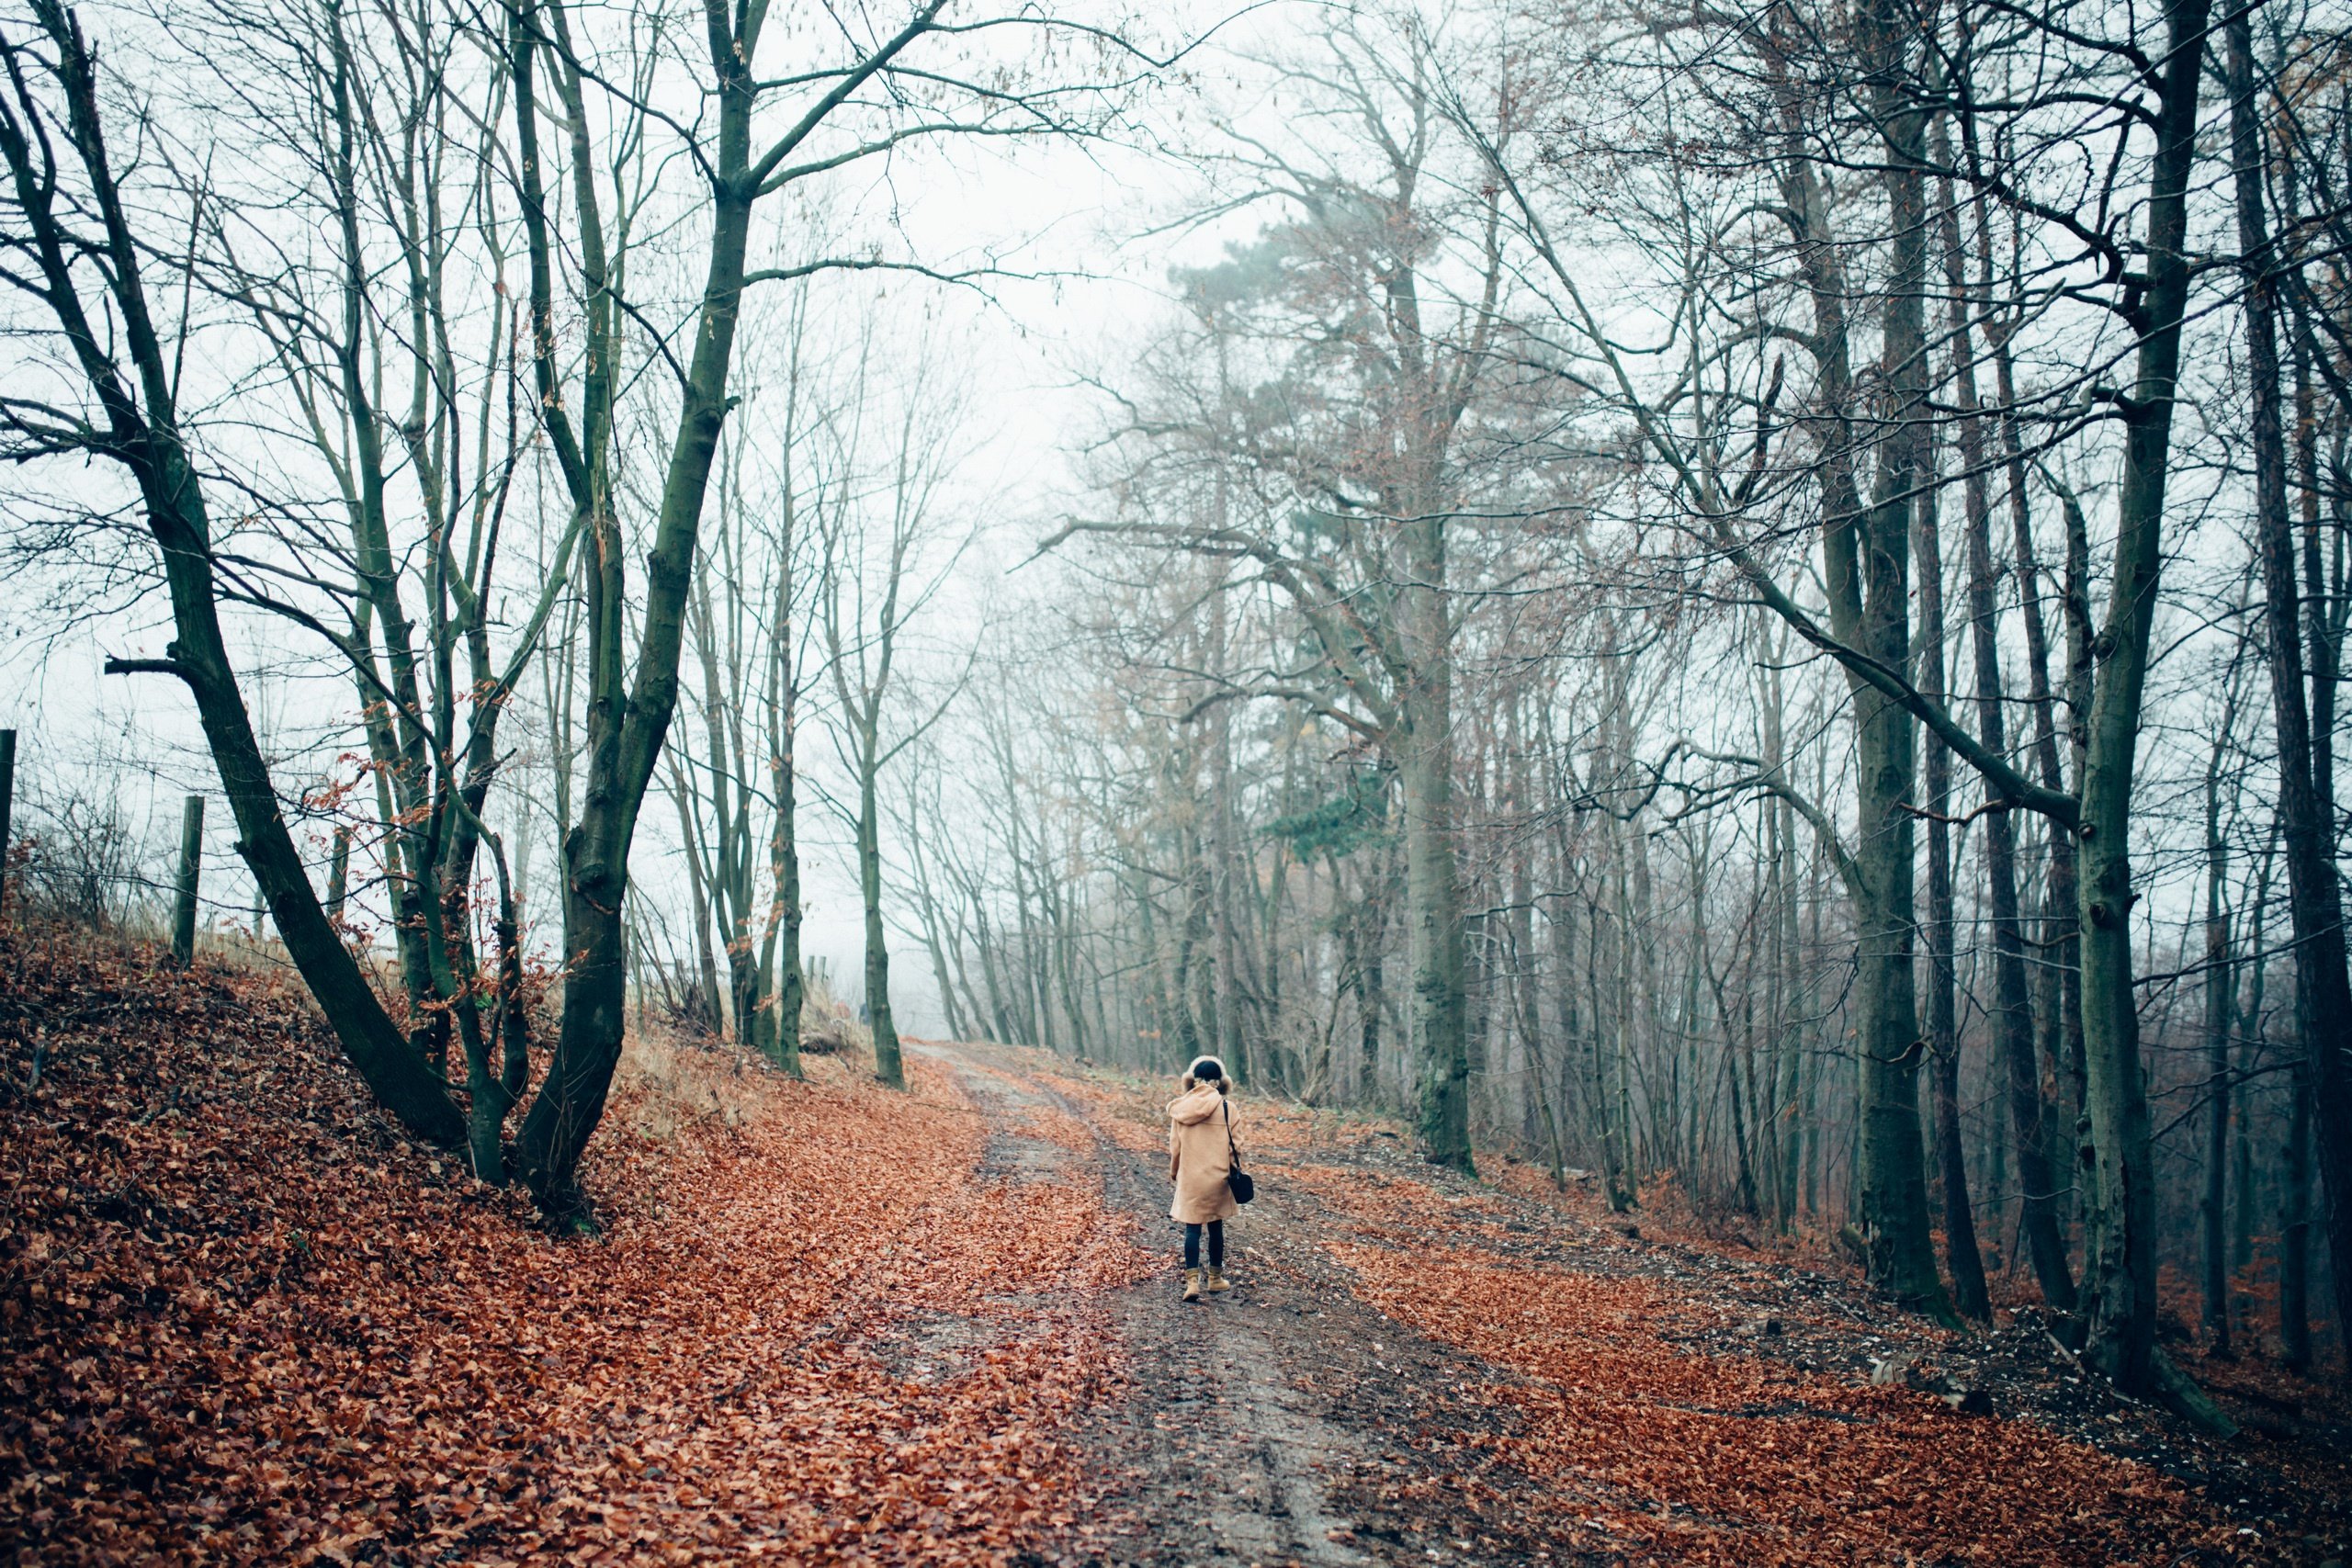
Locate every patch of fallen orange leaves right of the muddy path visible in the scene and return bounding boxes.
[1331,1241,2232,1563]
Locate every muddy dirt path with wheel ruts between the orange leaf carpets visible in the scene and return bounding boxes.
[910,1046,1589,1568]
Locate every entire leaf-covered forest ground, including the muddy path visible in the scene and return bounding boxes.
[0,931,2352,1568]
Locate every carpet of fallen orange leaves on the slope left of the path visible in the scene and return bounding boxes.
[0,942,1138,1563]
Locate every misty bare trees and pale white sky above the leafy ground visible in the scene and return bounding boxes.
[0,0,2352,1420]
